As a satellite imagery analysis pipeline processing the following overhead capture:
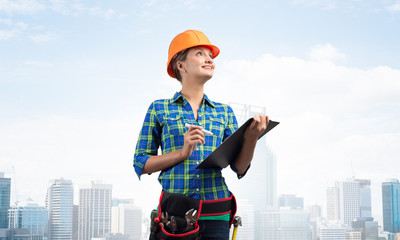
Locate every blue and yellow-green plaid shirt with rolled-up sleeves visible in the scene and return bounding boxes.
[133,93,238,200]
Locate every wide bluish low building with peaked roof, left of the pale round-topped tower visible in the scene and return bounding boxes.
[8,199,48,239]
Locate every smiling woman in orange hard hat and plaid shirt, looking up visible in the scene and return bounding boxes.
[134,30,268,239]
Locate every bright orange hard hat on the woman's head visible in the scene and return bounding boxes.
[167,30,219,78]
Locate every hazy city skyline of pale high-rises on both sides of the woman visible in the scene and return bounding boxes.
[0,172,400,240]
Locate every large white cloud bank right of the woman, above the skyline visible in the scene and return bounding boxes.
[206,51,400,208]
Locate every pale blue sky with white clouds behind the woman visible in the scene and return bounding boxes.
[0,0,400,223]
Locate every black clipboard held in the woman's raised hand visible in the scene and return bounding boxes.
[196,118,279,169]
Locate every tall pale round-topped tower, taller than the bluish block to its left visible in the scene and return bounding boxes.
[46,178,74,240]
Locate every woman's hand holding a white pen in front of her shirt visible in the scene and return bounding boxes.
[182,125,205,159]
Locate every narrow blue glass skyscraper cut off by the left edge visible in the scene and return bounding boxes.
[0,172,11,228]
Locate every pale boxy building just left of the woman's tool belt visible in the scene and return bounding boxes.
[111,202,142,240]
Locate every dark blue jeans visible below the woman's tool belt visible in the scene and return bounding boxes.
[198,220,229,240]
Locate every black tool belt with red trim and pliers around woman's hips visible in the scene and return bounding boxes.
[150,191,236,240]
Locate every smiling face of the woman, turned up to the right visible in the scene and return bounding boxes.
[177,47,215,81]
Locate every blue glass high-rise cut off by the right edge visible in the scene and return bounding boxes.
[382,179,400,233]
